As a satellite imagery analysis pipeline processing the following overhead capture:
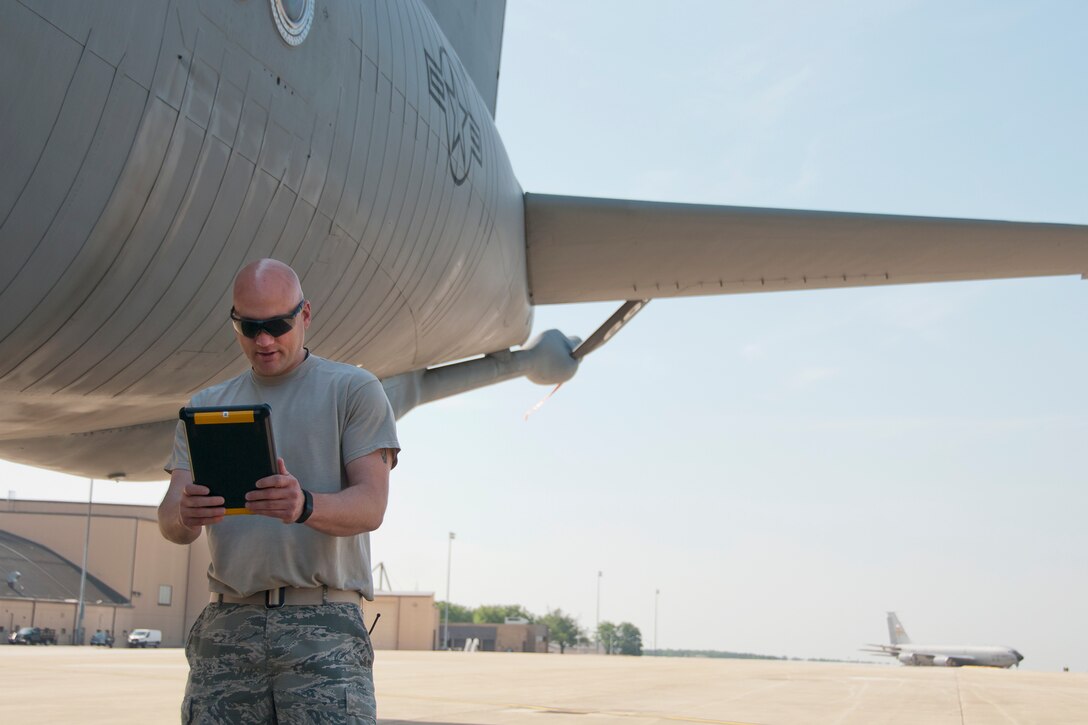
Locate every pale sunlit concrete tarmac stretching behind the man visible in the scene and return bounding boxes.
[0,647,1088,725]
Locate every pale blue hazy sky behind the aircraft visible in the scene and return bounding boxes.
[0,0,1088,672]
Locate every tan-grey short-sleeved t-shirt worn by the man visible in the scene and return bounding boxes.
[166,355,400,600]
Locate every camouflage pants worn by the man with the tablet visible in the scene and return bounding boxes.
[182,602,375,725]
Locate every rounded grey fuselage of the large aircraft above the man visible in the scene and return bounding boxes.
[0,0,531,479]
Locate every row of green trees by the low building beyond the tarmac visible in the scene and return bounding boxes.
[435,602,642,656]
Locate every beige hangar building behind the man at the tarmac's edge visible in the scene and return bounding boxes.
[0,500,438,650]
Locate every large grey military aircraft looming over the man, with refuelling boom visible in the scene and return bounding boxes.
[0,0,1088,480]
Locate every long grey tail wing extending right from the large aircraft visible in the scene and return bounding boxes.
[524,194,1088,305]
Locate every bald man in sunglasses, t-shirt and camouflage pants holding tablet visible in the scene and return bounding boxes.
[159,259,400,725]
